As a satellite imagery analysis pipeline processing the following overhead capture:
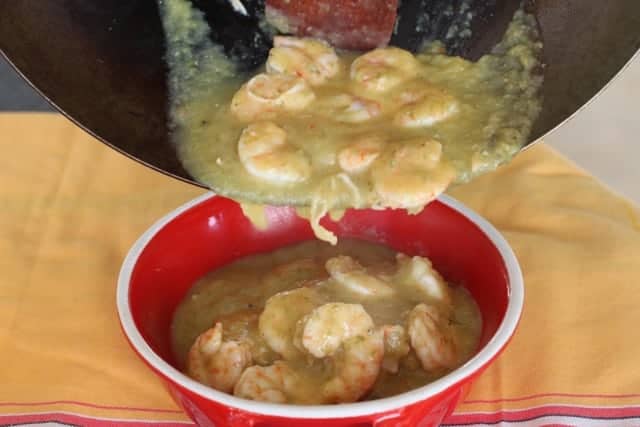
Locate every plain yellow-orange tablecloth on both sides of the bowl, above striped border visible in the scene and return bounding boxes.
[0,114,640,425]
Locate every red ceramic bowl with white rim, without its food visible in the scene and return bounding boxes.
[117,194,524,427]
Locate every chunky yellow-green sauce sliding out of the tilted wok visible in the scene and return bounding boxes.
[160,0,542,242]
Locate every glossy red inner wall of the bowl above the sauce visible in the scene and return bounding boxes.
[129,197,509,367]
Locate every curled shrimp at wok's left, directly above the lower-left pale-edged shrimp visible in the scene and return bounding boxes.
[231,74,316,122]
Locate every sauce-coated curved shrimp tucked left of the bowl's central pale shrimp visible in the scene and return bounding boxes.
[258,287,323,360]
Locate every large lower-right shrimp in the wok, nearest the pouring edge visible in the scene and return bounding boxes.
[371,139,455,209]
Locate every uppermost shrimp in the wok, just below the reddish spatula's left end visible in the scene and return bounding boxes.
[266,36,340,86]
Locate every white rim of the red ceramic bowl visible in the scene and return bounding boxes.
[116,192,524,419]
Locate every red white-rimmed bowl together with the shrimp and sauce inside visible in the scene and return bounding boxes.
[118,195,523,427]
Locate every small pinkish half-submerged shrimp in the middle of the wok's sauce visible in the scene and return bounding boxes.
[317,93,382,123]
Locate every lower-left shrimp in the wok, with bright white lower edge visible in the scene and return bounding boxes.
[238,122,311,184]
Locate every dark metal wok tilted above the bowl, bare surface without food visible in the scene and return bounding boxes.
[0,0,640,184]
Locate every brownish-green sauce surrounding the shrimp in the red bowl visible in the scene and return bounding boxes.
[171,239,482,403]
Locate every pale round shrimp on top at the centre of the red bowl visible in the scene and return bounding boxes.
[299,302,374,358]
